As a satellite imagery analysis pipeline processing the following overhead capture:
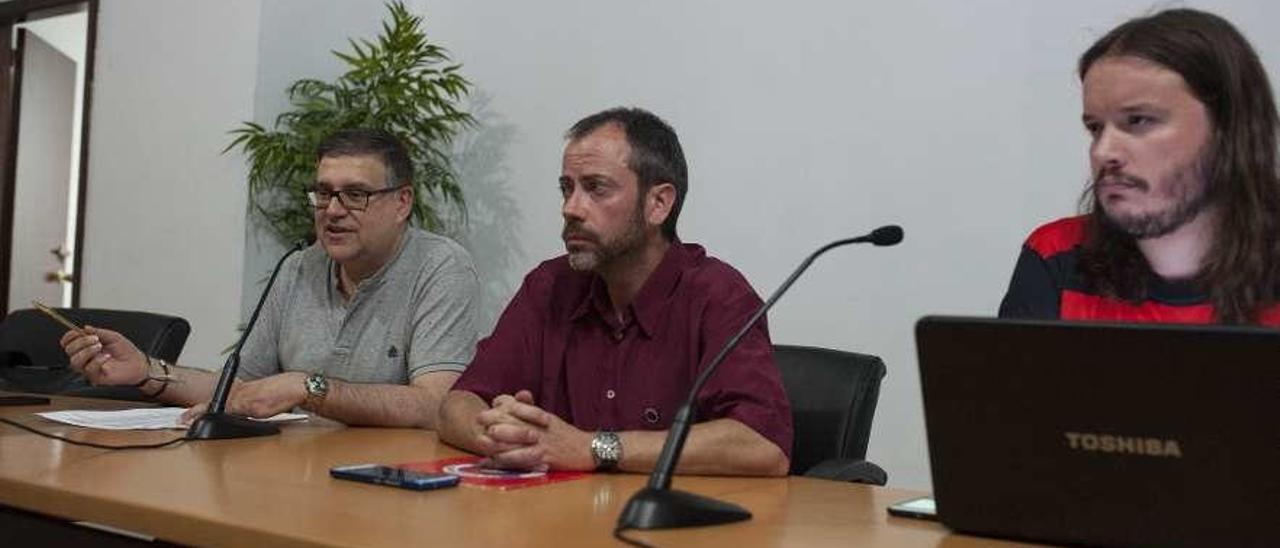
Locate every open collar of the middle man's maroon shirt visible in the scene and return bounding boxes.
[571,239,707,338]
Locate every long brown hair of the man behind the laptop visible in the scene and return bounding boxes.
[1079,9,1280,324]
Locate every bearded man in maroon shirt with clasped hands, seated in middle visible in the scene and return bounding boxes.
[440,109,791,475]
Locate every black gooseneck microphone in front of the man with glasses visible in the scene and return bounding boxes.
[187,239,307,439]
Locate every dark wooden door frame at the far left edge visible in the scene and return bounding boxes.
[0,0,99,315]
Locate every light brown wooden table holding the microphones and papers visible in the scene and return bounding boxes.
[0,397,1029,548]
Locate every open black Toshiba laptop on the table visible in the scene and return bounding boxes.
[915,316,1280,547]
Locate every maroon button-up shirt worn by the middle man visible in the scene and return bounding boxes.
[453,242,791,456]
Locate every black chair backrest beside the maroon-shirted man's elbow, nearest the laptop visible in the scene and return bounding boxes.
[773,344,886,474]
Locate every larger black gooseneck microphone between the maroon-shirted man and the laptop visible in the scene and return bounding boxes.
[617,224,902,531]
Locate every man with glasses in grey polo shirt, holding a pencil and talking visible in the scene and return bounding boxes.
[61,129,479,428]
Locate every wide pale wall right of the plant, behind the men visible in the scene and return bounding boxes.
[417,0,1280,488]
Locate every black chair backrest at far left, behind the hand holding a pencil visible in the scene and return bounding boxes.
[0,309,191,367]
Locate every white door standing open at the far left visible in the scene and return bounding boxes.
[0,0,96,312]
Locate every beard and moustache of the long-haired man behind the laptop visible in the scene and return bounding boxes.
[1093,155,1213,239]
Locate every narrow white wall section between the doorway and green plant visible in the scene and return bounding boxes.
[81,0,259,366]
